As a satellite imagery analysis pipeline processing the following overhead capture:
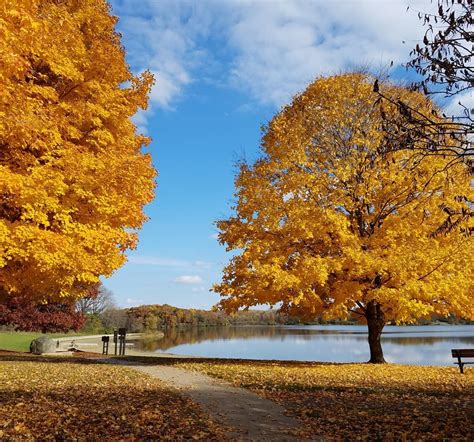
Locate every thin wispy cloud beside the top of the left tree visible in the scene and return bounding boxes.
[112,0,210,108]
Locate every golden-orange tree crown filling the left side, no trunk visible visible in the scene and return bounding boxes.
[0,0,155,303]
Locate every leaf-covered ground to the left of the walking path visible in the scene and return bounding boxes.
[0,361,224,441]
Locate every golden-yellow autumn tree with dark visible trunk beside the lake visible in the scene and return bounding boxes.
[214,74,474,362]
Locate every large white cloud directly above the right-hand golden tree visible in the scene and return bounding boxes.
[225,0,423,106]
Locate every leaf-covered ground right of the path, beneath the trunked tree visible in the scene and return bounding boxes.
[180,361,474,440]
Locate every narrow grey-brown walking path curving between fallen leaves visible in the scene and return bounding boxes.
[113,361,300,441]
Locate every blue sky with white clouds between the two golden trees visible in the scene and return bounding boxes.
[104,0,444,308]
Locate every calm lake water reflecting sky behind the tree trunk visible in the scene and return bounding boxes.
[137,325,474,365]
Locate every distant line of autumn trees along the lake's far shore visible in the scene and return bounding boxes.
[0,284,472,334]
